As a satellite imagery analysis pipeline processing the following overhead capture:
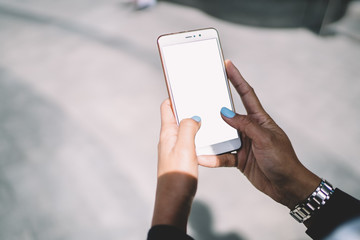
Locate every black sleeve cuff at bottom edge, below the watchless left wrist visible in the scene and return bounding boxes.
[147,225,193,240]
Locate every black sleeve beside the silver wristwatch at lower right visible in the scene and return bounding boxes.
[306,189,360,239]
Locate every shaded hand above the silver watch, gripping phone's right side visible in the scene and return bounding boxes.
[199,61,321,209]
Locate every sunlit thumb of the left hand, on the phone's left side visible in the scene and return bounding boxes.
[176,116,201,149]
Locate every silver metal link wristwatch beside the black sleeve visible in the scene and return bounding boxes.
[290,179,335,223]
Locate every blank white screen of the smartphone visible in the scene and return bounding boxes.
[163,38,238,147]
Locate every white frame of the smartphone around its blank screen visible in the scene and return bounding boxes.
[157,28,241,155]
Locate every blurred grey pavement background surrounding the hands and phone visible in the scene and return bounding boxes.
[0,0,360,240]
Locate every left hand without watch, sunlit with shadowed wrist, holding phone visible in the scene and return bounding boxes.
[152,99,201,232]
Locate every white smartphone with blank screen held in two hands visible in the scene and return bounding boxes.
[157,28,241,155]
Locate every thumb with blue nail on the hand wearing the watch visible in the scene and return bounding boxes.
[221,107,267,142]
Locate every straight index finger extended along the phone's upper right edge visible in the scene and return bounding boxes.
[225,60,265,114]
